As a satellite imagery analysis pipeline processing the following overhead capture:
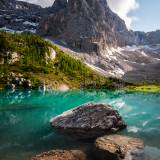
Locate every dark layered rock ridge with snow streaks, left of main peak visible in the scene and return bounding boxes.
[0,0,44,33]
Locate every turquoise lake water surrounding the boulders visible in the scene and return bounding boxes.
[0,91,160,160]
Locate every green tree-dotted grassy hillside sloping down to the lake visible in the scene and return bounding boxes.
[0,32,122,89]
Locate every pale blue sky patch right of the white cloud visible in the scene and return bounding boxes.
[128,0,160,31]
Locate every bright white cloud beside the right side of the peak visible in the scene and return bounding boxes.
[107,0,139,29]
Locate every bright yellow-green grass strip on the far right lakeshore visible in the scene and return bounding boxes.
[125,85,160,92]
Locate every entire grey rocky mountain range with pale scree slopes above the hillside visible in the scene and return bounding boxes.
[0,0,160,83]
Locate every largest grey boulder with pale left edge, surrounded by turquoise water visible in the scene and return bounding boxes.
[50,103,126,139]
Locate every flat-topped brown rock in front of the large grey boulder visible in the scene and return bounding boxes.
[95,135,144,160]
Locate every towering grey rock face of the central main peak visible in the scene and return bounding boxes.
[37,0,130,53]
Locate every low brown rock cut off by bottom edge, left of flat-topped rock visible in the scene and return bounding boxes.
[32,150,87,160]
